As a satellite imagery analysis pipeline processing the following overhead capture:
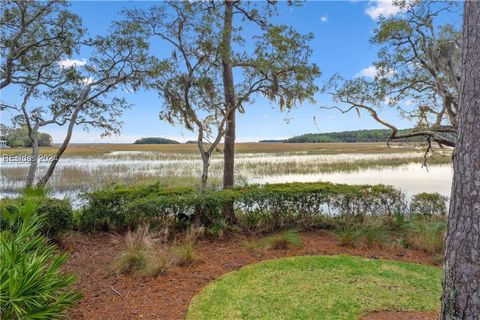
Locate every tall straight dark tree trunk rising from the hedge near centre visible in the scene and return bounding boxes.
[222,0,237,223]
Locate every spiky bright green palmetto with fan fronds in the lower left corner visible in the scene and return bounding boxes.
[0,200,81,319]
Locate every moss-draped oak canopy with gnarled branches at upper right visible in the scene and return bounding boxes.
[324,1,461,150]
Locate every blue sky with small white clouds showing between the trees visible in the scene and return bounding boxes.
[1,1,462,143]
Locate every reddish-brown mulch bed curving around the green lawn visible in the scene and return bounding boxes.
[63,231,437,320]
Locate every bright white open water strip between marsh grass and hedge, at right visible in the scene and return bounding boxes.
[249,163,453,198]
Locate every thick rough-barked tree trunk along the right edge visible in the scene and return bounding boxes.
[441,1,480,320]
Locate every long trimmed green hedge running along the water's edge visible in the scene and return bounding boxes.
[80,182,407,231]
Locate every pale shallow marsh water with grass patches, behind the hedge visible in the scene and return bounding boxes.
[0,151,453,198]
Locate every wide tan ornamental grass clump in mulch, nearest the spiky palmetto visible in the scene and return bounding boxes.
[112,227,169,277]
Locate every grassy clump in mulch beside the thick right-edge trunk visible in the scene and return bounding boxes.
[406,220,447,254]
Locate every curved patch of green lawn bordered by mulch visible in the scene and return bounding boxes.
[187,256,441,320]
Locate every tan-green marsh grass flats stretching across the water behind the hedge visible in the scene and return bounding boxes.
[0,144,451,192]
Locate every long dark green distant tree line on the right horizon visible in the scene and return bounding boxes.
[260,129,456,143]
